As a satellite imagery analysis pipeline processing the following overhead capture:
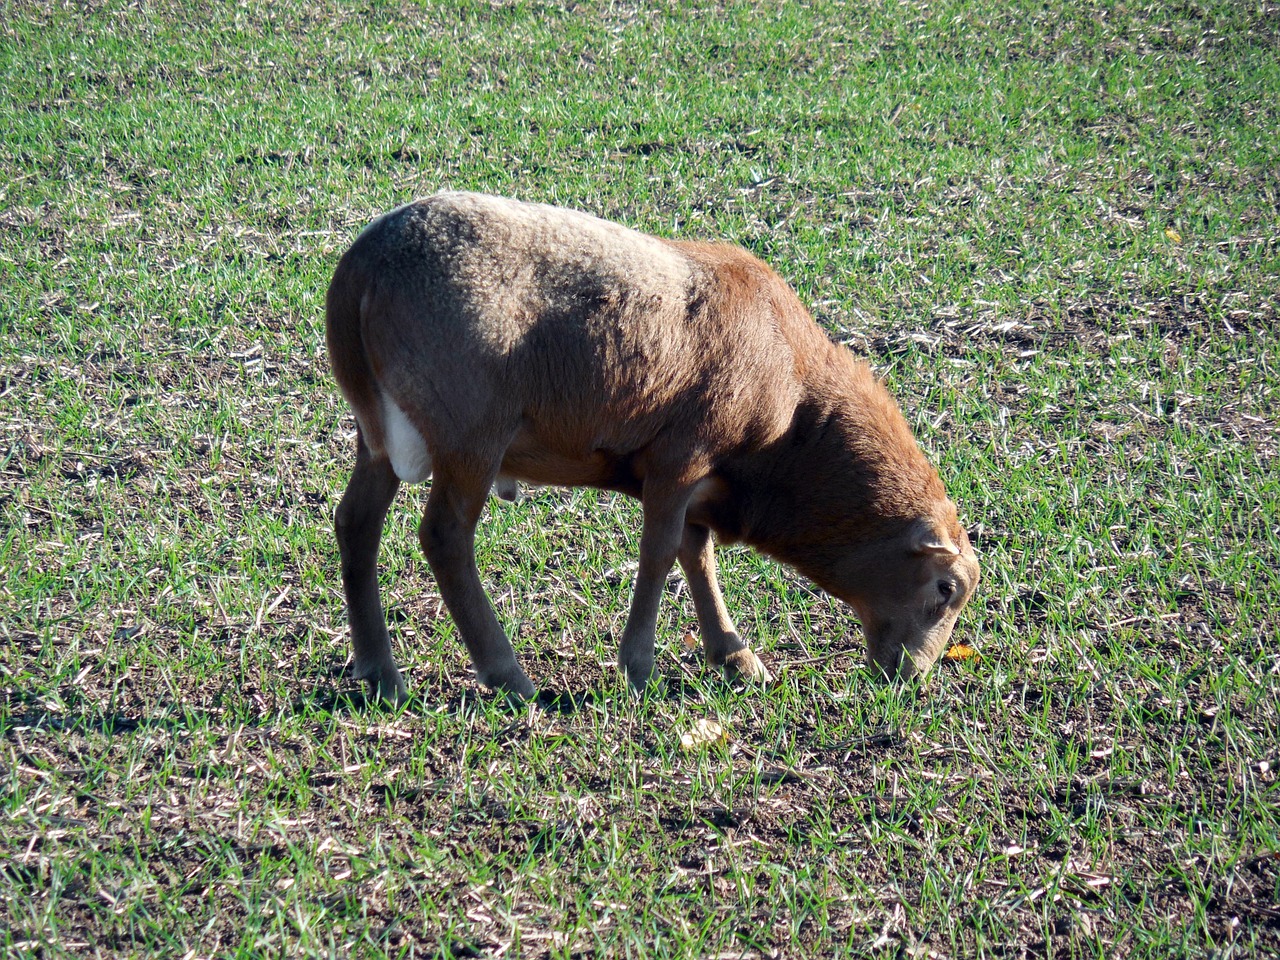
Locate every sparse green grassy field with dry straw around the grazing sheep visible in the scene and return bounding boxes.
[0,0,1280,957]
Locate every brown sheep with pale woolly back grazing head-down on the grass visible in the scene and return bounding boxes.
[328,193,978,698]
